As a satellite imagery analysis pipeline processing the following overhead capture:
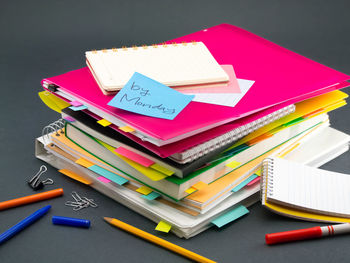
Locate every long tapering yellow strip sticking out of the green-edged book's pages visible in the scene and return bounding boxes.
[96,139,168,181]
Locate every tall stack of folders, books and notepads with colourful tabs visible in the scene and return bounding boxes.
[36,25,350,238]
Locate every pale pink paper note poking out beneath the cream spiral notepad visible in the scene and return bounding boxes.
[175,65,241,94]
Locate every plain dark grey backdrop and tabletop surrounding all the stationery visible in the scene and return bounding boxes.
[0,0,350,263]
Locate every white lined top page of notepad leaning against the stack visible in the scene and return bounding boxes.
[267,158,350,217]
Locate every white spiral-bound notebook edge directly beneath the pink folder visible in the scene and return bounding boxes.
[182,104,295,162]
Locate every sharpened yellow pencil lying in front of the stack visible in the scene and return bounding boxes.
[104,217,215,263]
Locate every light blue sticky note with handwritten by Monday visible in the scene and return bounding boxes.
[108,72,194,120]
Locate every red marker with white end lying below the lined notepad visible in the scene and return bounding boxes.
[265,223,350,245]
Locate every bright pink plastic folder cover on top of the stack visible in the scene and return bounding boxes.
[43,24,350,141]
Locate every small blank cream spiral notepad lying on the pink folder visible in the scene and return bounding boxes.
[86,42,229,91]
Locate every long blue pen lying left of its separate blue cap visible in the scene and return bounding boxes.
[0,205,51,245]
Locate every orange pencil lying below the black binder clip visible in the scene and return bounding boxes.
[0,188,63,211]
